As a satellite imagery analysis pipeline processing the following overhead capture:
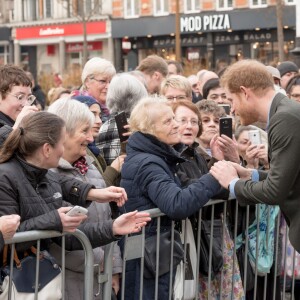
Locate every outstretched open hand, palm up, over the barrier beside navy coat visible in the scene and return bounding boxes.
[112,210,151,235]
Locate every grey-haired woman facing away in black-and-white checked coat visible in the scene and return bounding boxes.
[96,73,148,165]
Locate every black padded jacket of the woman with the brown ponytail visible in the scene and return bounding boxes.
[0,156,115,250]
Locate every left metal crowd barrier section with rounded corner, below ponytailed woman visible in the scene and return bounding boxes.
[5,230,94,300]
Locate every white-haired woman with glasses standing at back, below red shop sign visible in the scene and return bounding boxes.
[72,57,116,122]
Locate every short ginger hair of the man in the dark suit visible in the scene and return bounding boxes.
[221,59,274,96]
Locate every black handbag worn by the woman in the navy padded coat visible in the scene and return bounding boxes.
[144,230,184,278]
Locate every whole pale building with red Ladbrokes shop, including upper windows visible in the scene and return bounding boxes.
[0,0,113,76]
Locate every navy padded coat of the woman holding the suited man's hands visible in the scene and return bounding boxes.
[121,132,220,219]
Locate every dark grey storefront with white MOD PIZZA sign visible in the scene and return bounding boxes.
[112,6,296,74]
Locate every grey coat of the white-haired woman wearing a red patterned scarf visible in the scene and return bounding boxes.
[50,156,122,300]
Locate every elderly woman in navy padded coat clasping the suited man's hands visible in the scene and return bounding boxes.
[120,97,220,300]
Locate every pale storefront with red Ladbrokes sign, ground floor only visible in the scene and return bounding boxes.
[14,20,113,74]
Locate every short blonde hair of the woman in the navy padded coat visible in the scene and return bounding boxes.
[129,96,170,135]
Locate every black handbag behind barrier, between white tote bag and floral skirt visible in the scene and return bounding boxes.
[199,219,223,277]
